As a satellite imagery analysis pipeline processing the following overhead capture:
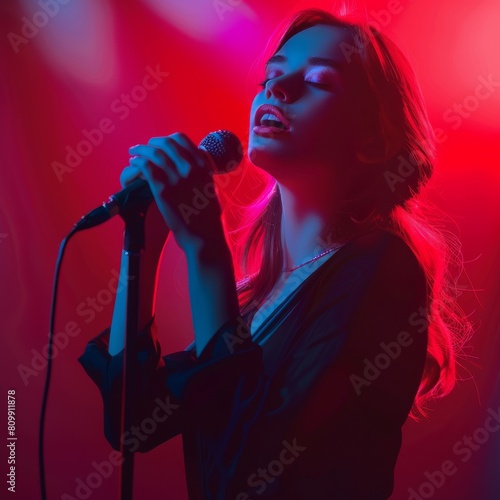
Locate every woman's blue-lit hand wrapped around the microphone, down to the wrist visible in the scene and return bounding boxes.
[126,133,224,252]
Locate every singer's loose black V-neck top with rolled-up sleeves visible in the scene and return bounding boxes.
[78,229,428,500]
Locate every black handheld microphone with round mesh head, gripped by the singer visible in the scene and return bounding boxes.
[73,130,243,231]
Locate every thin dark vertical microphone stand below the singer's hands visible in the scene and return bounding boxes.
[120,201,150,500]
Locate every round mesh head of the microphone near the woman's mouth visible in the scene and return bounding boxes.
[198,130,243,174]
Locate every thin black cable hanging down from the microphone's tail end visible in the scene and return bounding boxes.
[38,227,78,500]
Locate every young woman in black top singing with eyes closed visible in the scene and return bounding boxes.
[79,10,467,500]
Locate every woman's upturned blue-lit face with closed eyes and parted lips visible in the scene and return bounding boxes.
[248,25,366,181]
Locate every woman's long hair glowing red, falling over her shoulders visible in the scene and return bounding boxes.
[226,9,471,419]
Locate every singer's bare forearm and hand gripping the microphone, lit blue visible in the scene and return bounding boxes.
[120,134,239,356]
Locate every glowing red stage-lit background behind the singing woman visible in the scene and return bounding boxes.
[0,0,500,500]
